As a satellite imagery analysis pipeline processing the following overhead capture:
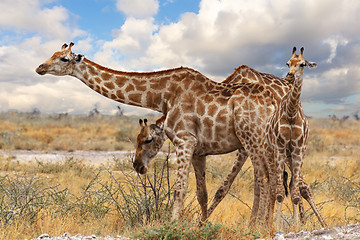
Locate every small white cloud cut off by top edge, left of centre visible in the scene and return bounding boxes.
[116,0,159,18]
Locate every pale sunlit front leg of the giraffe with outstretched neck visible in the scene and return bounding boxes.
[172,134,196,220]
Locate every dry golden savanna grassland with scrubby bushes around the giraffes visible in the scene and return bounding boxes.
[0,113,360,239]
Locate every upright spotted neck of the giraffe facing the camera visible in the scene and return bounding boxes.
[286,72,303,119]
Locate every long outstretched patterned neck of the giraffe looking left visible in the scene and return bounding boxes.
[71,58,195,113]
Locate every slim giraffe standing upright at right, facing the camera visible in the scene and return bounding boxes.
[266,47,317,230]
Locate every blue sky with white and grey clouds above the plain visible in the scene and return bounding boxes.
[0,0,360,118]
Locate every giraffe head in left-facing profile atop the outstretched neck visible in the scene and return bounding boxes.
[35,43,84,76]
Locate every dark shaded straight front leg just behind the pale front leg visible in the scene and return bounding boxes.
[192,156,208,224]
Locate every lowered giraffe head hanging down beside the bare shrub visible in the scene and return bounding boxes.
[133,117,166,174]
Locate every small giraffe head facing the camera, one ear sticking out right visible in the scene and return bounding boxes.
[286,47,317,82]
